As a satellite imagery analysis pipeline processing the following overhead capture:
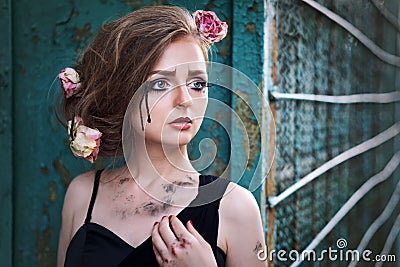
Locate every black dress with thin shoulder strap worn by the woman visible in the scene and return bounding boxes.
[64,170,229,267]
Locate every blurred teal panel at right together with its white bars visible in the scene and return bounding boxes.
[264,0,400,266]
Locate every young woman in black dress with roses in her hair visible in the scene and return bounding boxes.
[58,6,266,267]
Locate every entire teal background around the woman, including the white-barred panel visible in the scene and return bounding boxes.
[0,0,400,266]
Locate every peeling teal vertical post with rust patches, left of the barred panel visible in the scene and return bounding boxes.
[231,1,264,202]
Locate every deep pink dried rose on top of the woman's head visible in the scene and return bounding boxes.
[193,10,228,44]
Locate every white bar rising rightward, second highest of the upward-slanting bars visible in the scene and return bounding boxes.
[290,151,400,267]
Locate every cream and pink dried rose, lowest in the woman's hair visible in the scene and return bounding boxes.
[68,116,102,163]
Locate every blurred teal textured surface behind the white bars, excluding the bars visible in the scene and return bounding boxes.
[267,0,398,266]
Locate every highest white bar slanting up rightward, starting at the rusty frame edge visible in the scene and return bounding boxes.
[268,122,400,208]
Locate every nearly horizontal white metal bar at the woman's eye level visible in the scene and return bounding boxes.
[270,91,400,104]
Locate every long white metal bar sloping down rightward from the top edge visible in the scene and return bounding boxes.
[301,0,400,67]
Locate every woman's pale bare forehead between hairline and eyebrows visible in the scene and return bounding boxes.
[153,38,206,71]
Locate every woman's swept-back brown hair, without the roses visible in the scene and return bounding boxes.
[62,6,210,157]
